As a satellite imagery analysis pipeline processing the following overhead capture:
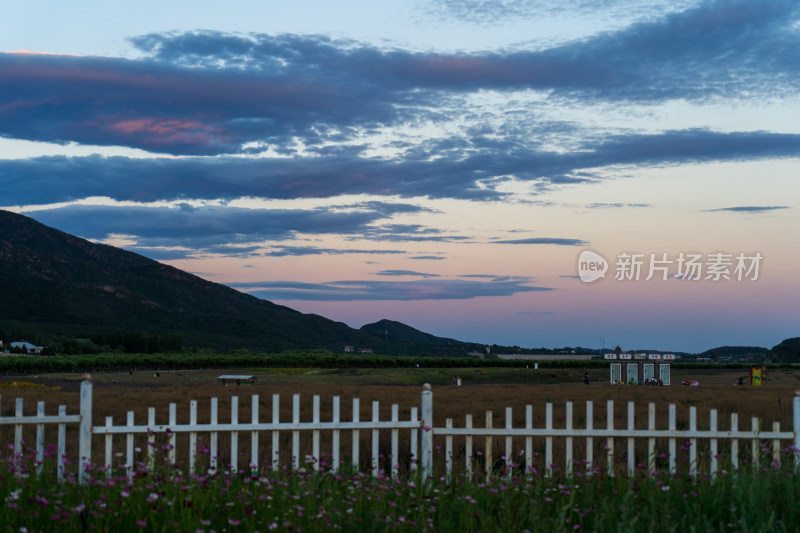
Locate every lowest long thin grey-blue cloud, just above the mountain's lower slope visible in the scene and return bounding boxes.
[228,279,554,301]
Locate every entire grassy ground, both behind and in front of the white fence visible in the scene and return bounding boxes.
[0,368,800,532]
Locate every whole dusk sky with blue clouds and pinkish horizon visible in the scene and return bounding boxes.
[0,0,800,352]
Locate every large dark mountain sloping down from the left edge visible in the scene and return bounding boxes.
[0,210,382,351]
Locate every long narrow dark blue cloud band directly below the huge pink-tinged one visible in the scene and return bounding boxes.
[0,129,800,206]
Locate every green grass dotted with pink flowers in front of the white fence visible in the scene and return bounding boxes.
[0,444,800,533]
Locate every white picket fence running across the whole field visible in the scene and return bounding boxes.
[0,381,800,483]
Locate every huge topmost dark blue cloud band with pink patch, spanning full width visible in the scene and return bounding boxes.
[0,0,800,156]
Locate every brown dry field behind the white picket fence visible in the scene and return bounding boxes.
[0,368,800,474]
